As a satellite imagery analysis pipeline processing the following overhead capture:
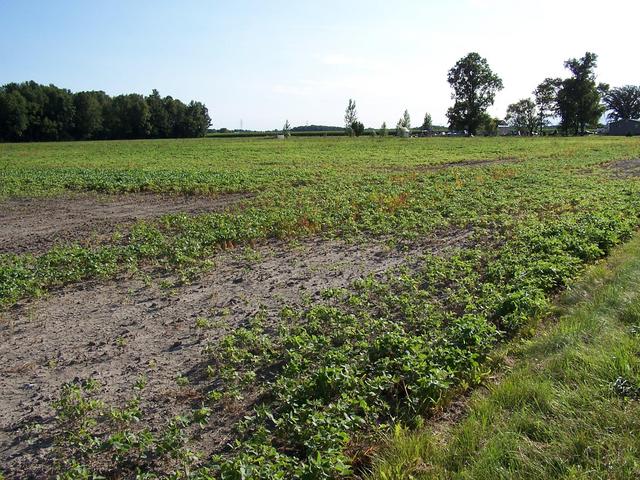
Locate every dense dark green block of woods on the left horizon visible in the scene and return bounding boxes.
[0,81,211,141]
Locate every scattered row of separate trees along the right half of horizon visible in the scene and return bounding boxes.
[344,52,640,136]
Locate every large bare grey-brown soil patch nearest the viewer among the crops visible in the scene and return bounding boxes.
[0,231,472,478]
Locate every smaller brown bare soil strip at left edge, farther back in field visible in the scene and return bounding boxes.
[0,193,250,254]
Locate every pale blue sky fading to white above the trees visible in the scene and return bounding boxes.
[0,0,640,130]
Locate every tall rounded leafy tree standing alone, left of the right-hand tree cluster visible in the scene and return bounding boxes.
[447,52,503,135]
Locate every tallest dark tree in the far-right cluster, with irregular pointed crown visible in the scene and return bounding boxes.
[557,52,608,135]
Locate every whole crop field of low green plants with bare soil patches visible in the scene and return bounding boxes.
[0,137,640,479]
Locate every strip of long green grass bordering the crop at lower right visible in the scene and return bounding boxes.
[369,228,640,480]
